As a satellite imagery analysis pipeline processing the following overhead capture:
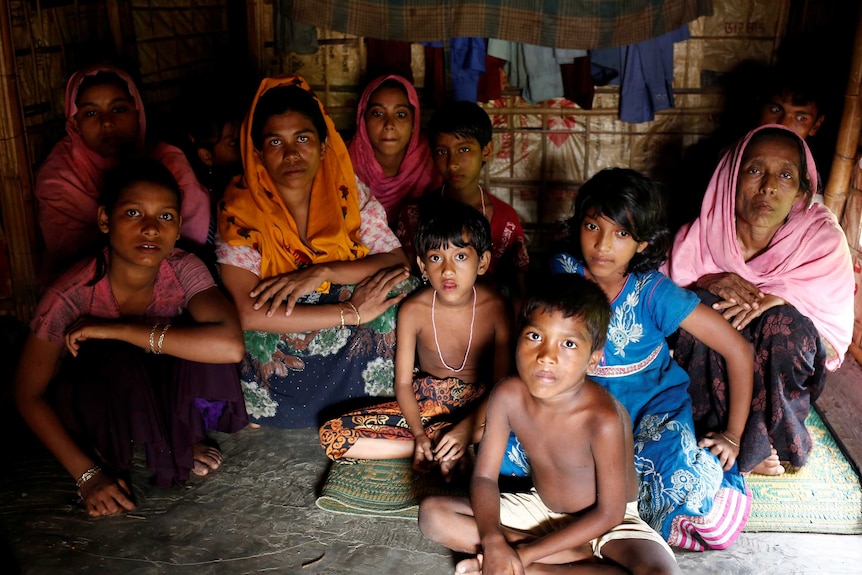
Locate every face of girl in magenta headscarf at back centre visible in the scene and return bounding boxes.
[365,88,413,165]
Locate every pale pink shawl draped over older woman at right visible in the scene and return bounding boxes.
[665,124,854,370]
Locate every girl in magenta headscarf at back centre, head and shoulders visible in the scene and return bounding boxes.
[348,74,441,227]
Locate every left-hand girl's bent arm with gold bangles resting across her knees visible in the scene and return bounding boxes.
[66,286,245,363]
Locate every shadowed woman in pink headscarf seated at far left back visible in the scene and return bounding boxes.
[35,65,210,281]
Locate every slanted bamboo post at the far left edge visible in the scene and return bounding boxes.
[0,0,37,321]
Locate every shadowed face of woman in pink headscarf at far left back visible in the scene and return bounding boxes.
[72,84,140,157]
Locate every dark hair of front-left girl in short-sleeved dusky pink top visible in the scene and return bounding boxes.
[87,158,183,286]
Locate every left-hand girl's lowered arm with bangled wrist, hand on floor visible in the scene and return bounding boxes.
[15,334,135,516]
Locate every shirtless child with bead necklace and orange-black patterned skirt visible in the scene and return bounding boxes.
[320,199,511,478]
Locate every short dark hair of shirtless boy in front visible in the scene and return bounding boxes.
[521,274,611,352]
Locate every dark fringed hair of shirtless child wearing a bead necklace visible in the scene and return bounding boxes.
[413,195,491,258]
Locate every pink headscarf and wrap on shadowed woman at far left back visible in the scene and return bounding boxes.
[34,65,210,279]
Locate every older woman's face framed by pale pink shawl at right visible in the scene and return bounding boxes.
[736,137,804,232]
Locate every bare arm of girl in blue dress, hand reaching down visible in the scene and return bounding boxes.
[680,304,754,470]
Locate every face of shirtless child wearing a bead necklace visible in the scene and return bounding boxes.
[416,234,491,304]
